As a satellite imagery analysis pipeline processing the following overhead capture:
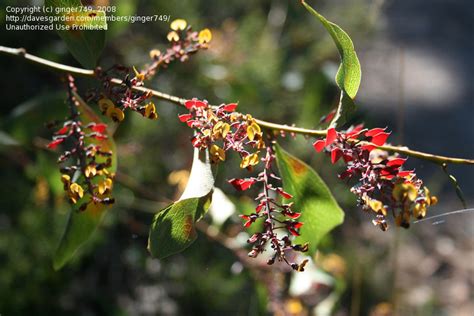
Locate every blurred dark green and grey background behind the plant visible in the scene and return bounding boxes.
[0,0,474,316]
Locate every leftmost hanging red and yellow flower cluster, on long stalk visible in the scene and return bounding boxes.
[48,76,114,211]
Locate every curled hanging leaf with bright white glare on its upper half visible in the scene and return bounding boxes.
[148,149,215,259]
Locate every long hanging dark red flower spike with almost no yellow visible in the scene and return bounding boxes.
[229,146,308,271]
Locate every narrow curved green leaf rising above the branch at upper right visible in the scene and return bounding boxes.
[301,1,362,127]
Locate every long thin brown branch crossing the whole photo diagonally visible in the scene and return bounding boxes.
[0,46,474,165]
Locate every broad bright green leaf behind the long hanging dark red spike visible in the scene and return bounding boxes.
[275,144,344,255]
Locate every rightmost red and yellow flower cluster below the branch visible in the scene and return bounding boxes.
[313,125,437,231]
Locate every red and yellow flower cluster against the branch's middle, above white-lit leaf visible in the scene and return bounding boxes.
[179,99,265,170]
